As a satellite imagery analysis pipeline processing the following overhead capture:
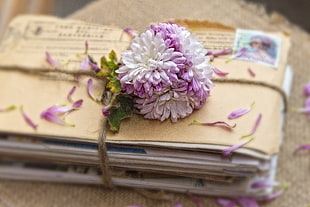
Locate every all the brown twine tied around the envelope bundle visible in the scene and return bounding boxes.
[0,66,288,188]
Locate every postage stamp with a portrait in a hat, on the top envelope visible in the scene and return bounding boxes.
[233,29,281,67]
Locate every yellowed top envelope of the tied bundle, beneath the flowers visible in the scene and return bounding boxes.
[0,16,290,155]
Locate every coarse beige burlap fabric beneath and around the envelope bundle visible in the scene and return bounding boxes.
[0,0,310,207]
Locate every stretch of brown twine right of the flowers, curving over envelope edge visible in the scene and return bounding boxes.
[212,78,288,112]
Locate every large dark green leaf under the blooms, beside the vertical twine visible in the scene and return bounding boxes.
[108,94,134,132]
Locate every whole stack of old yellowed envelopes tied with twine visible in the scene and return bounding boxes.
[0,16,292,198]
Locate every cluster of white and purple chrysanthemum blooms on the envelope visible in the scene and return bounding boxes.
[116,23,213,122]
